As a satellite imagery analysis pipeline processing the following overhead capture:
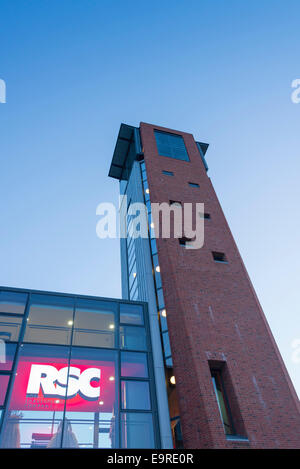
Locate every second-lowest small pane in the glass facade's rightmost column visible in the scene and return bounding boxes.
[121,381,151,410]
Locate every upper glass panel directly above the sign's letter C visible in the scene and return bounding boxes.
[73,300,117,348]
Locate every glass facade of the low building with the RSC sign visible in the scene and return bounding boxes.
[0,289,160,448]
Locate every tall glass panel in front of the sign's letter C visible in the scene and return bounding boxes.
[63,348,118,448]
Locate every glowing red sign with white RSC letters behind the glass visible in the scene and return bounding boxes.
[10,357,115,412]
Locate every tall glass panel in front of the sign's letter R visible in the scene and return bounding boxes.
[1,344,68,448]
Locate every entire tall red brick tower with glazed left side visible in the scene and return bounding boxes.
[110,123,300,448]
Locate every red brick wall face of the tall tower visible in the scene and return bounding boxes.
[140,123,300,448]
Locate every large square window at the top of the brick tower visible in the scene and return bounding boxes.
[154,130,190,161]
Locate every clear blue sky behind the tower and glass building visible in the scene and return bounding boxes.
[0,0,300,395]
